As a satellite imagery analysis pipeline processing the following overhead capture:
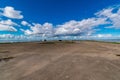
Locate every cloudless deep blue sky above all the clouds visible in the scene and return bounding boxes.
[0,0,120,24]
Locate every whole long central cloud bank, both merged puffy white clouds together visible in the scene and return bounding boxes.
[21,18,107,37]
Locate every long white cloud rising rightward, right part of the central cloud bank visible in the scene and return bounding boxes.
[55,18,107,35]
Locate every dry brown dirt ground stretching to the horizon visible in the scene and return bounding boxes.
[0,41,120,80]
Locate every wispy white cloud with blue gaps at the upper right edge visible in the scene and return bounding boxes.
[96,7,120,29]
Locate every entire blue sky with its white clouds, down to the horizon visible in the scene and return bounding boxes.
[0,0,120,40]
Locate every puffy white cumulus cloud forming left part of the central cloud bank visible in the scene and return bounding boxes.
[21,23,53,36]
